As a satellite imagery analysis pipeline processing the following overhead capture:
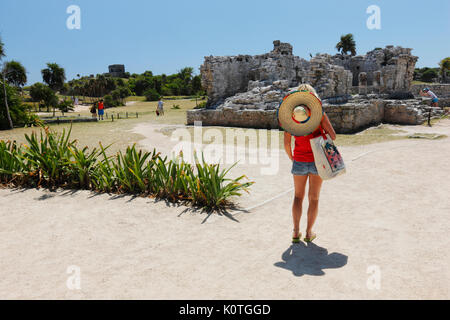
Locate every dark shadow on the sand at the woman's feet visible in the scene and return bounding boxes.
[274,242,348,277]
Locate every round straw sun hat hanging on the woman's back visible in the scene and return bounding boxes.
[278,91,323,136]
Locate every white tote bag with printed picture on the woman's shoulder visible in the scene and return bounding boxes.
[309,127,345,180]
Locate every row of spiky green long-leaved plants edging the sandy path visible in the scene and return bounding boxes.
[0,128,253,208]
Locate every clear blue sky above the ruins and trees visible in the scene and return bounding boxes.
[0,0,450,83]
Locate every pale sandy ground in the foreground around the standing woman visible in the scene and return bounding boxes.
[0,120,450,299]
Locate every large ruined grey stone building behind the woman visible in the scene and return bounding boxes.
[187,40,450,133]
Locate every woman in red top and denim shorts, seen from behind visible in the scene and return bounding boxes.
[284,84,336,243]
